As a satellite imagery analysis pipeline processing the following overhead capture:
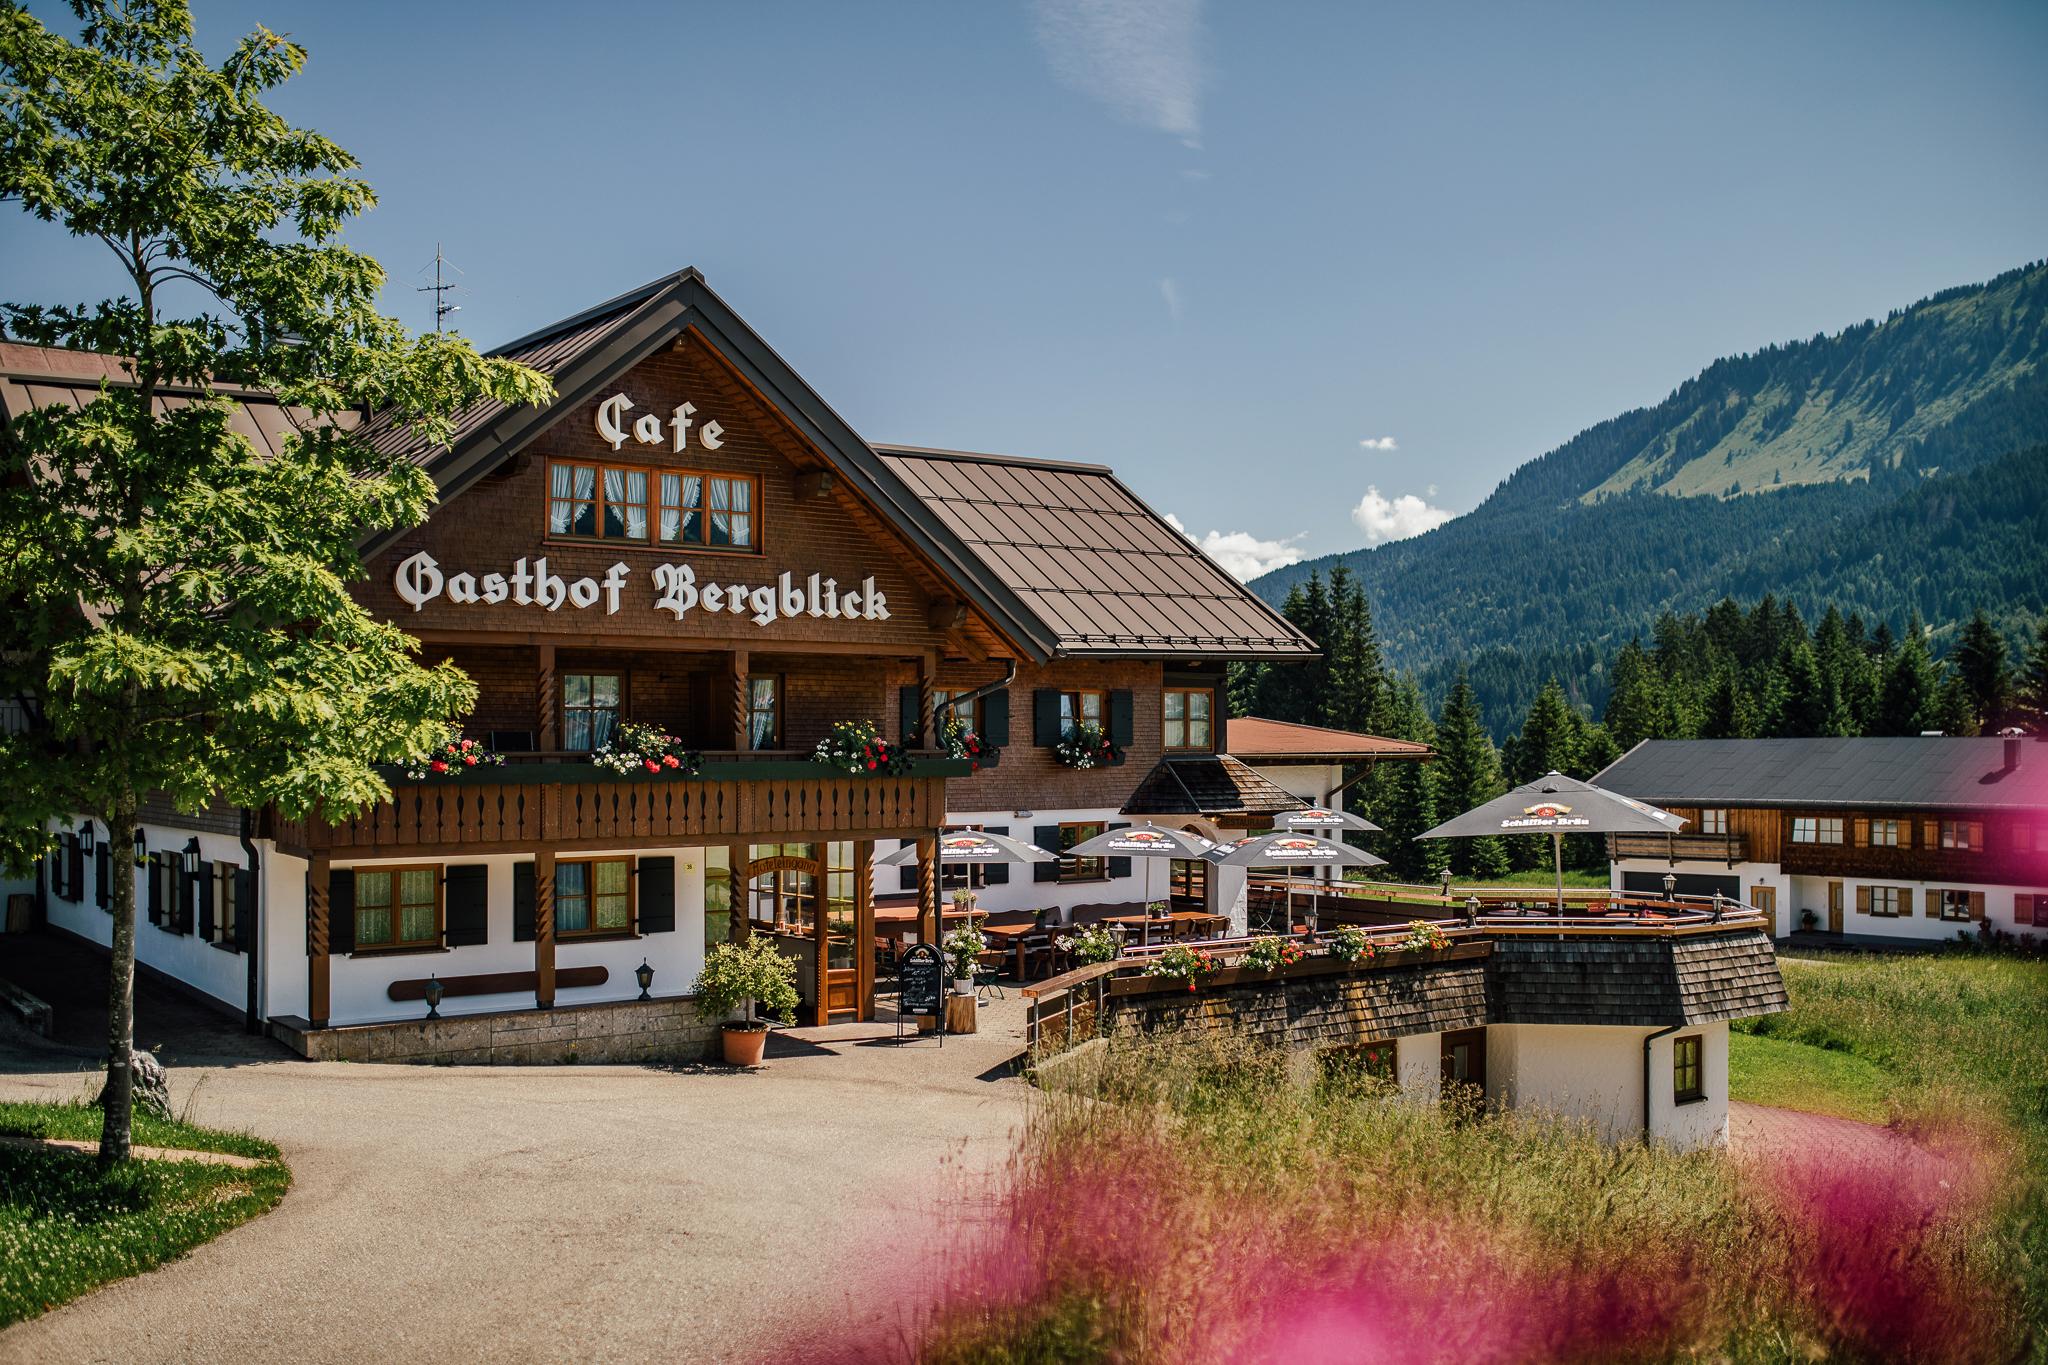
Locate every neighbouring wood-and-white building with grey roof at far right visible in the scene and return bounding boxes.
[1593,735,2048,941]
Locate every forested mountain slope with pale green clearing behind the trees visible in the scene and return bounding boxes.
[1253,262,2048,729]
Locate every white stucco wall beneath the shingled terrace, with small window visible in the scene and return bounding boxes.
[1487,1023,1729,1150]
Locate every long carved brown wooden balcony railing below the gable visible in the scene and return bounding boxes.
[264,753,969,857]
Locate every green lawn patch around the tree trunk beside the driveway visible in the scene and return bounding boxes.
[0,1101,291,1326]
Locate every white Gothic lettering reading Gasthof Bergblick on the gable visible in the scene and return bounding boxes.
[391,551,889,626]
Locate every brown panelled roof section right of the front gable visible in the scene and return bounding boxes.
[874,446,1315,659]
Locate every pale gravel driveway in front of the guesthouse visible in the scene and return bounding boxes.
[0,982,1024,1365]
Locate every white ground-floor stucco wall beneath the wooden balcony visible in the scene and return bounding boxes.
[311,849,705,1023]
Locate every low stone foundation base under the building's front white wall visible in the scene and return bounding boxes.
[270,997,719,1066]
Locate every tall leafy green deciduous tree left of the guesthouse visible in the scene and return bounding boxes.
[0,0,547,1162]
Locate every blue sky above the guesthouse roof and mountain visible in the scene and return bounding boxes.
[0,0,2048,573]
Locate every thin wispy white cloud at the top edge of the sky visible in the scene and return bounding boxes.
[1032,0,1202,147]
